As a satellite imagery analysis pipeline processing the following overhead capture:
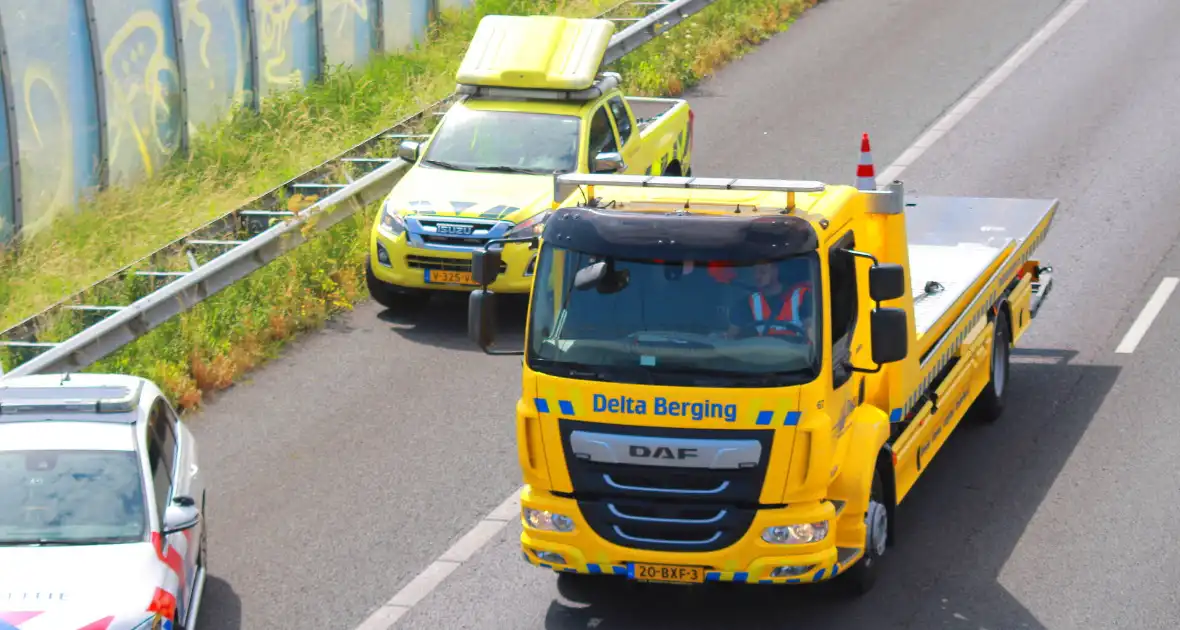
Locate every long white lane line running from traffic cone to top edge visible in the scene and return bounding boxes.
[877,0,1089,188]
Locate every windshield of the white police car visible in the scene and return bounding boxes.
[0,451,148,545]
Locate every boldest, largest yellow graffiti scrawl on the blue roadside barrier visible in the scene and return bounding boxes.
[103,11,179,177]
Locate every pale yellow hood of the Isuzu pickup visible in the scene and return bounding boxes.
[387,166,553,223]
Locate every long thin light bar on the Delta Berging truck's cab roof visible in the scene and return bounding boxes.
[553,173,827,209]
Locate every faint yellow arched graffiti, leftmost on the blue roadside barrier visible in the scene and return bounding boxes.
[21,60,74,232]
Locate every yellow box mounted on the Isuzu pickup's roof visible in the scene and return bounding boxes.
[457,15,615,91]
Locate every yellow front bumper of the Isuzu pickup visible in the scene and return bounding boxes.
[369,229,537,294]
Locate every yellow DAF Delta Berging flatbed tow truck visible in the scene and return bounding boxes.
[468,150,1057,593]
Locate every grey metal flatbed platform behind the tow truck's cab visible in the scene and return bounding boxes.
[905,196,1057,355]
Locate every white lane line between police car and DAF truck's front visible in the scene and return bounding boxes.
[356,486,524,630]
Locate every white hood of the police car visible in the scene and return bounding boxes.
[0,543,168,630]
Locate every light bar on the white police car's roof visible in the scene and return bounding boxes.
[0,383,143,415]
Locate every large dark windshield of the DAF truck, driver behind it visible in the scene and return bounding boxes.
[527,244,821,387]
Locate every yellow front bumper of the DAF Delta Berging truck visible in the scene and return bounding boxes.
[520,486,863,584]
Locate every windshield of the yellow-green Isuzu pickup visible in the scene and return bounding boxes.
[422,109,582,175]
